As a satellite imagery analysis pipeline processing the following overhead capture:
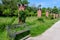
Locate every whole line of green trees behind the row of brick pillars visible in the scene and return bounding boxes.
[0,0,60,16]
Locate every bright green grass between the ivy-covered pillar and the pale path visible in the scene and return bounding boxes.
[26,17,58,36]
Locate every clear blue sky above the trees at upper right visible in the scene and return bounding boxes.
[28,0,60,7]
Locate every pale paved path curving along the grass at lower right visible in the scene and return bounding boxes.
[27,21,60,40]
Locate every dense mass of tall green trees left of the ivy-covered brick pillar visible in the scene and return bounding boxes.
[0,0,28,16]
